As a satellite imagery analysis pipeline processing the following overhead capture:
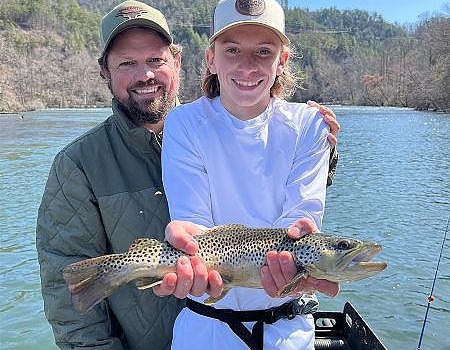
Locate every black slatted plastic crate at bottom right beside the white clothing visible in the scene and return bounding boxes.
[313,302,387,350]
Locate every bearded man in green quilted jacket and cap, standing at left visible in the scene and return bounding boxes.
[36,1,184,349]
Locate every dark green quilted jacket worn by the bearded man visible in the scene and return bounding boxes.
[36,100,184,350]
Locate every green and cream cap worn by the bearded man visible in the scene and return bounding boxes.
[100,0,173,57]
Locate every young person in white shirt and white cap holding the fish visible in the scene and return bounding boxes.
[162,0,337,350]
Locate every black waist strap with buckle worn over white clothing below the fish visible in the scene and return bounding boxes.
[186,298,318,350]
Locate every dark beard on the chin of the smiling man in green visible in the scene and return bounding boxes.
[117,88,175,126]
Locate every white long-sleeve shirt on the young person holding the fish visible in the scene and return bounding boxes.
[162,97,329,349]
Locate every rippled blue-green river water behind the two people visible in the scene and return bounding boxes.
[0,106,450,350]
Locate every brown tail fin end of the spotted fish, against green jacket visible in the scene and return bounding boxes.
[63,254,128,314]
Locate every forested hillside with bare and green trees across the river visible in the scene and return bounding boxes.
[0,0,450,112]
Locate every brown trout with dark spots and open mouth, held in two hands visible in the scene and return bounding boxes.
[63,225,387,313]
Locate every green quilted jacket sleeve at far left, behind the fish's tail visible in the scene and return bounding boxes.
[36,151,123,350]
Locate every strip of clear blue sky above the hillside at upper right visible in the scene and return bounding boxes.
[286,0,450,24]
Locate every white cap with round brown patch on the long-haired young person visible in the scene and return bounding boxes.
[209,0,290,44]
